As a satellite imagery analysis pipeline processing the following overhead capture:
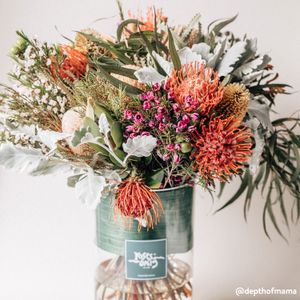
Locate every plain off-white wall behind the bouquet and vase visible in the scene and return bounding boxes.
[0,0,300,300]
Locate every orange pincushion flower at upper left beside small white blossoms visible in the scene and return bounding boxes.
[50,45,88,81]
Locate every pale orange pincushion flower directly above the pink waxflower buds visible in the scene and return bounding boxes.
[167,63,223,116]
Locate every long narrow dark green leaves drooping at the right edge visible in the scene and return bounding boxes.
[218,118,300,238]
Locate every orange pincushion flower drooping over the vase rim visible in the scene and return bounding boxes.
[115,177,163,231]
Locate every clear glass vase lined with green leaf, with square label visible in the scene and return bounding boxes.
[95,186,193,300]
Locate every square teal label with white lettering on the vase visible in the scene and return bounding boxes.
[125,239,167,280]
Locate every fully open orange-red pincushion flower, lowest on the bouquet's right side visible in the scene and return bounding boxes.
[191,117,252,181]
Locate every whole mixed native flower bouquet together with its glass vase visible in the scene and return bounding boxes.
[0,2,300,299]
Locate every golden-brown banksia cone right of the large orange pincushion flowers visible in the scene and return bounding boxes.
[216,83,250,122]
